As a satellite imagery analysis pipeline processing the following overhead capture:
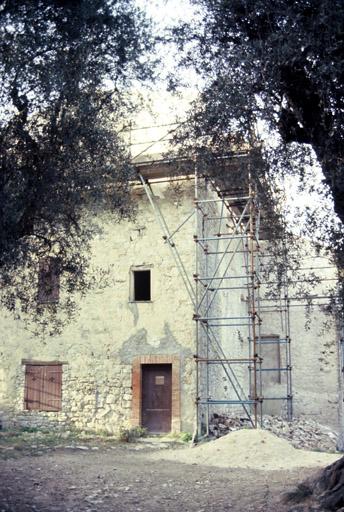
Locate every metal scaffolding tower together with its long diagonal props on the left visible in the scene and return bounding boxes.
[138,160,291,433]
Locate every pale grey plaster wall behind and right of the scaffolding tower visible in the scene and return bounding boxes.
[195,182,343,430]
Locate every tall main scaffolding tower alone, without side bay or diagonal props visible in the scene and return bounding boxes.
[194,170,259,433]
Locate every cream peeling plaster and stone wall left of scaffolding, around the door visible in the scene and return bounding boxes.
[0,183,195,432]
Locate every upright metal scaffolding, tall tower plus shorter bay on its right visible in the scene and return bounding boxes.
[194,162,292,432]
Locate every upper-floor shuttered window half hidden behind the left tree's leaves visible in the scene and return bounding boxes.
[38,257,60,304]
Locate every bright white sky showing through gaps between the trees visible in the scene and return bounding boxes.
[131,0,333,236]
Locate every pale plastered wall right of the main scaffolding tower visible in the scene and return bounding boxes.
[261,254,343,431]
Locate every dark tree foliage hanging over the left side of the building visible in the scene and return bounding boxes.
[0,0,153,331]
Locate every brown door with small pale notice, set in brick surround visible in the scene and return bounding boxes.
[142,364,172,434]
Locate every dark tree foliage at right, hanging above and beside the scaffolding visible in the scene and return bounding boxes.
[174,0,344,316]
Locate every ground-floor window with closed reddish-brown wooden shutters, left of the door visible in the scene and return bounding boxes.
[24,362,62,411]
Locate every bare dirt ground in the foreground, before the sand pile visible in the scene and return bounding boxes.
[0,442,322,512]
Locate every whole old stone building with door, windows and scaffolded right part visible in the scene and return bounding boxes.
[0,157,342,432]
